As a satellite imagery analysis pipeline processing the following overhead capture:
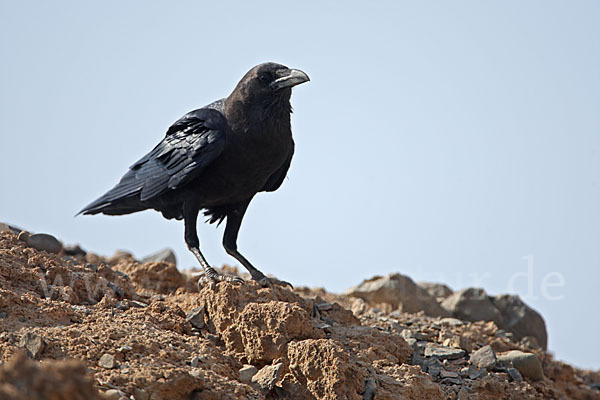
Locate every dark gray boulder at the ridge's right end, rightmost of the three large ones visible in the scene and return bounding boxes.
[493,294,548,350]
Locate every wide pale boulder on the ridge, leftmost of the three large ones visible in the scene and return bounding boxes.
[346,274,450,317]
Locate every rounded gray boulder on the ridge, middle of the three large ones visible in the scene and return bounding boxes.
[442,288,503,326]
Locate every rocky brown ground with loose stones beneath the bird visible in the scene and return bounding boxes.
[0,224,600,400]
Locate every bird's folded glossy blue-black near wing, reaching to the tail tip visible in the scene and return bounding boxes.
[81,108,227,214]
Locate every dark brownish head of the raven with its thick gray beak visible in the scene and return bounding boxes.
[226,62,310,111]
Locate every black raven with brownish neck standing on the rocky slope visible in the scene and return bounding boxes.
[79,63,309,287]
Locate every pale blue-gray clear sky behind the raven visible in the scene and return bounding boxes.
[0,0,600,369]
